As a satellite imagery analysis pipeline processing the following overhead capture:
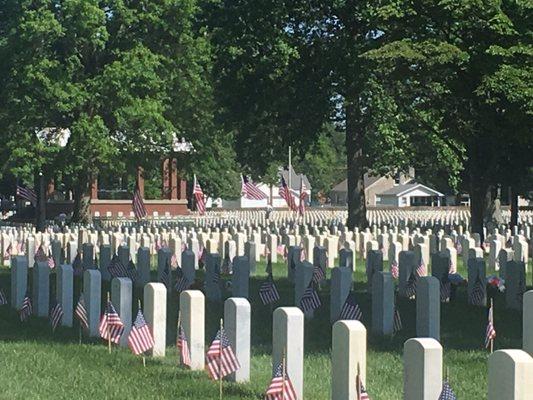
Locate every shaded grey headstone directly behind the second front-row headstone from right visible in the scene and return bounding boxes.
[416,276,440,340]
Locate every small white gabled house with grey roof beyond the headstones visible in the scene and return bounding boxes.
[376,183,444,207]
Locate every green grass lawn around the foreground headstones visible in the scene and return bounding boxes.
[0,259,531,400]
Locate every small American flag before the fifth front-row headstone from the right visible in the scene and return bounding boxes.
[206,328,241,380]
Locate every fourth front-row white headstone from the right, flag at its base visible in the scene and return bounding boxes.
[272,307,304,400]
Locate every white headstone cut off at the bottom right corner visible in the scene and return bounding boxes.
[488,350,533,400]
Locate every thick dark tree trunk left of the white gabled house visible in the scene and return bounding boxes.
[346,96,368,229]
